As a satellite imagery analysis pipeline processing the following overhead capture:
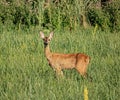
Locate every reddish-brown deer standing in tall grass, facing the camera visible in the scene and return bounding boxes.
[40,31,90,78]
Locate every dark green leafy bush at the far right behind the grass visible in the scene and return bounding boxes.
[87,1,120,31]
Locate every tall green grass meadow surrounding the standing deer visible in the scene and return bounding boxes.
[0,30,120,100]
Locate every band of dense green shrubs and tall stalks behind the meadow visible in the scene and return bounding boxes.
[0,0,120,31]
